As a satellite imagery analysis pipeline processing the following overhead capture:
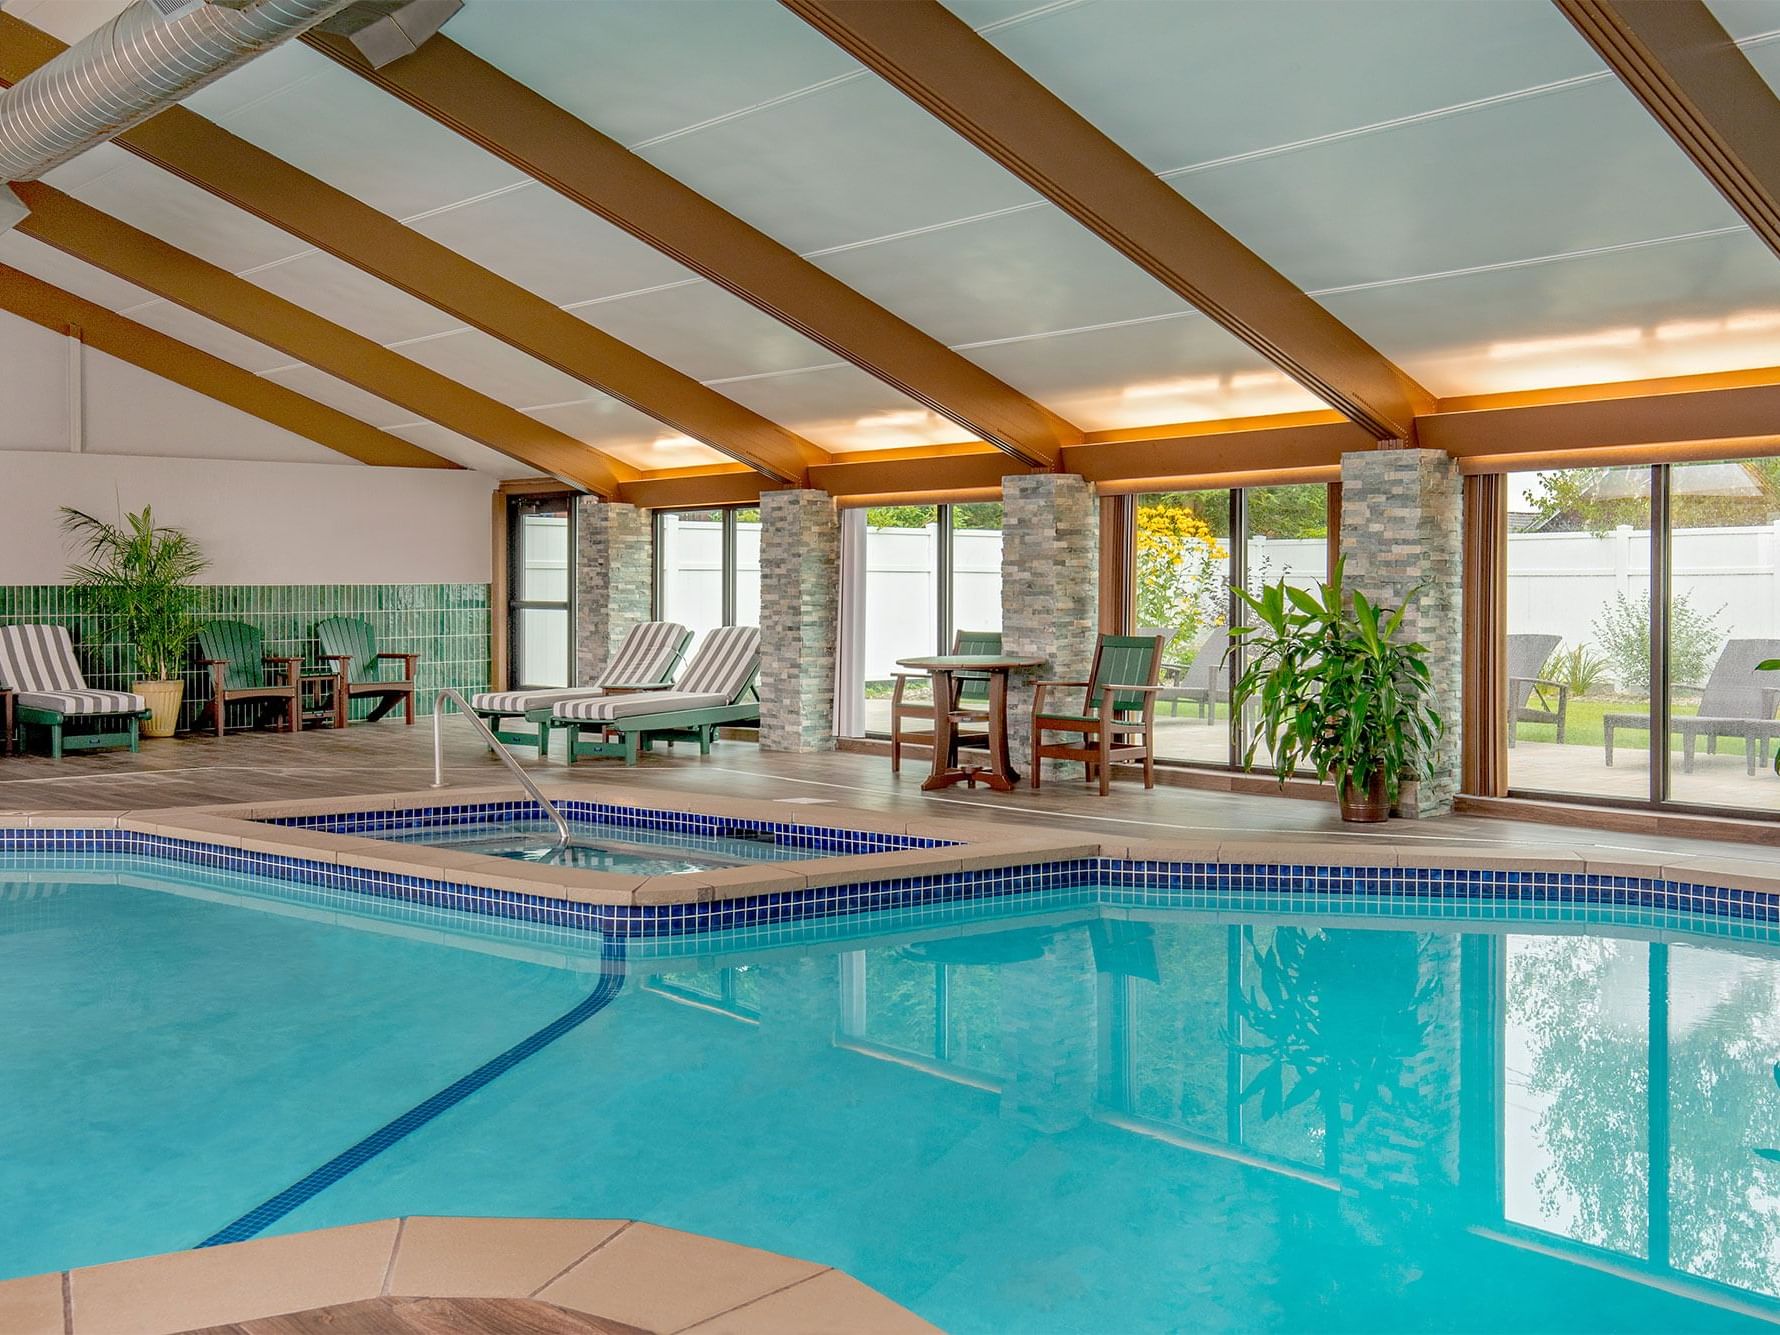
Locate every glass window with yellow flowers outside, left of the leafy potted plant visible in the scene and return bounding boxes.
[1132,484,1330,765]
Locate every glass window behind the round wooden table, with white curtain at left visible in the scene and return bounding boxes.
[842,500,1002,735]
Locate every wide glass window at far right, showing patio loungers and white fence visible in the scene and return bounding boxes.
[1506,459,1780,812]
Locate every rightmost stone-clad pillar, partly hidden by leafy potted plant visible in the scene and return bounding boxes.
[1340,449,1463,815]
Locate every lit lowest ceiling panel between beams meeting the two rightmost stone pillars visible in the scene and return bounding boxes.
[967,312,1324,431]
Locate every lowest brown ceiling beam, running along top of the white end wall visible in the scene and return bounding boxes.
[0,263,457,468]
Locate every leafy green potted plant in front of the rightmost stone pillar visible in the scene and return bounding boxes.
[1230,561,1445,821]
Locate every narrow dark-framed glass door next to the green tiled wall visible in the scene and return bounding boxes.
[507,495,573,691]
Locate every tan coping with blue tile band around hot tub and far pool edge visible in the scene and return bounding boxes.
[10,780,1780,936]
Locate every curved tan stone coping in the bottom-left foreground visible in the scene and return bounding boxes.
[0,1216,936,1335]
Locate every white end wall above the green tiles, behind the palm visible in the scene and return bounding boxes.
[0,313,495,584]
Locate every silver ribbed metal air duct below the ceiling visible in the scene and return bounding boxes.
[0,0,351,182]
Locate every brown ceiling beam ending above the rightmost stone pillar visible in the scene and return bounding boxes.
[781,0,1433,441]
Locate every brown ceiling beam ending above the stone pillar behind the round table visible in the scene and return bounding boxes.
[303,30,1082,468]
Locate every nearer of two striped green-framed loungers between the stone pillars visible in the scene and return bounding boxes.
[541,627,760,765]
